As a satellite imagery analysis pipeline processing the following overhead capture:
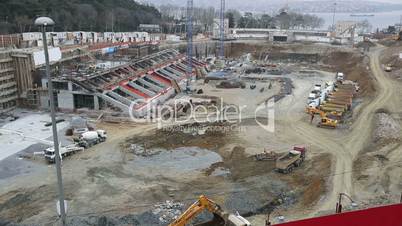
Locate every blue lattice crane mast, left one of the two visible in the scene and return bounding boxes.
[186,0,193,91]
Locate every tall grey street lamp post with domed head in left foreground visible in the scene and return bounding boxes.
[35,17,66,226]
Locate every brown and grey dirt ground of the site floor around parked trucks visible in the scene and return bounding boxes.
[0,41,402,225]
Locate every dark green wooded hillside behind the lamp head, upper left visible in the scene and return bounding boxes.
[0,0,161,34]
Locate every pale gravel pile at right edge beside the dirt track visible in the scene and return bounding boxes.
[373,113,401,143]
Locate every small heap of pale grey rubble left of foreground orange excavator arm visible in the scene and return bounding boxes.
[152,200,184,223]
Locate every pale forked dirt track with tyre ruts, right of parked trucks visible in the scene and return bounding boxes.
[286,47,400,215]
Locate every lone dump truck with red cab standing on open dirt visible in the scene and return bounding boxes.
[275,146,306,174]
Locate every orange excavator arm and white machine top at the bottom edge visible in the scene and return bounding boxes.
[169,195,251,226]
